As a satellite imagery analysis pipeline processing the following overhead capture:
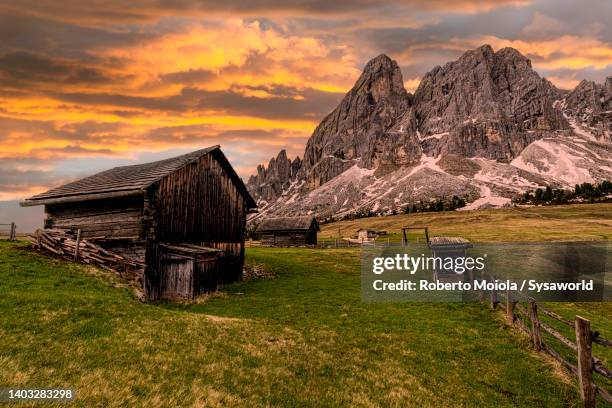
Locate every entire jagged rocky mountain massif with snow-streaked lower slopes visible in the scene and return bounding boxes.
[247,45,612,217]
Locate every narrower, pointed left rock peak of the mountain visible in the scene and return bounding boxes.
[300,55,420,190]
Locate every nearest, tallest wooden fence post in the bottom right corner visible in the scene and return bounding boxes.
[575,316,596,408]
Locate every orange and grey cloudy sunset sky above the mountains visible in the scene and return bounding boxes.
[0,0,612,201]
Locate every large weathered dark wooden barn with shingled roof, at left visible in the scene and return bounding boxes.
[21,146,256,300]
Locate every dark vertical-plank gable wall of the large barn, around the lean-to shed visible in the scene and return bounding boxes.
[152,153,246,293]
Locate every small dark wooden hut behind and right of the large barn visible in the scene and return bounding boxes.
[257,216,320,247]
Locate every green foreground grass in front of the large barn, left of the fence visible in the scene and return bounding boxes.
[0,244,579,407]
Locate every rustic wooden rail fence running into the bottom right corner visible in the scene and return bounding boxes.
[490,291,612,408]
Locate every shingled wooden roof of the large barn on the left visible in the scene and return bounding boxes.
[21,145,257,209]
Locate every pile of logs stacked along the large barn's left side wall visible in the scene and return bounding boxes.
[28,229,142,272]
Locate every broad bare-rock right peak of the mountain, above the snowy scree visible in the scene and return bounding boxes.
[414,45,568,162]
